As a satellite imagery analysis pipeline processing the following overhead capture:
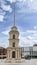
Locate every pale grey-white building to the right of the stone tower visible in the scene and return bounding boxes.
[21,44,37,59]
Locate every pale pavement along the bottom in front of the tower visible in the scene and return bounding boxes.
[0,59,37,65]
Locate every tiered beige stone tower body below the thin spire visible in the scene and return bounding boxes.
[7,26,21,62]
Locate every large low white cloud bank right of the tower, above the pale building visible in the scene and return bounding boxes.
[20,30,37,46]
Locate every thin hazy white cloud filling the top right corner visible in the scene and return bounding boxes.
[17,0,37,13]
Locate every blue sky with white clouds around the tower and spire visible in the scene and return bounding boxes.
[0,0,37,47]
